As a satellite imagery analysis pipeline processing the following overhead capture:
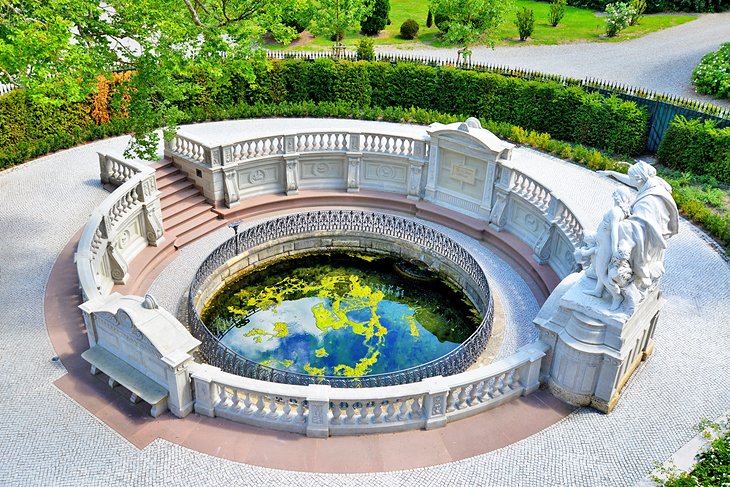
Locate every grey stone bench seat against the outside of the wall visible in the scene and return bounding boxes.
[81,345,168,418]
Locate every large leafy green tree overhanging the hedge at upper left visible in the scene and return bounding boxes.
[0,0,302,159]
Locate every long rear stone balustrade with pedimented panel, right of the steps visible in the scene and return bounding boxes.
[165,122,583,278]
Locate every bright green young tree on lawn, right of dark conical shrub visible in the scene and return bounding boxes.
[429,0,514,46]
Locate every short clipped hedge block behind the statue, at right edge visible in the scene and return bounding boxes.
[657,116,730,182]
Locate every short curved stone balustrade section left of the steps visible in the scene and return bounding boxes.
[76,154,163,300]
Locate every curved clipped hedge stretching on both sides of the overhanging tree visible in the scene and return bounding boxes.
[0,58,648,171]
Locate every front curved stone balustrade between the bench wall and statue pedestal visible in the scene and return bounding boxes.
[191,342,549,437]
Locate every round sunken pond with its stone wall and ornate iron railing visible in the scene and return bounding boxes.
[188,210,494,387]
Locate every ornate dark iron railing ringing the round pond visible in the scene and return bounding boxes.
[188,210,494,388]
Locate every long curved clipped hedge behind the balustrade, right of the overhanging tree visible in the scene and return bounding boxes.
[242,59,648,155]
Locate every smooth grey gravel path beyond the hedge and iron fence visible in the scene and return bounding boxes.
[379,12,730,108]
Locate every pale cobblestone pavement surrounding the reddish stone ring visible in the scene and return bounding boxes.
[0,121,730,486]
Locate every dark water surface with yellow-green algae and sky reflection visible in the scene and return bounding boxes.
[202,253,481,376]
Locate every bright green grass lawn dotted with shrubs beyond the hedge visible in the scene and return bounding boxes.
[267,0,697,50]
